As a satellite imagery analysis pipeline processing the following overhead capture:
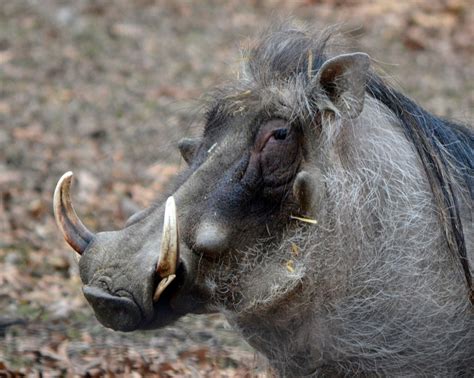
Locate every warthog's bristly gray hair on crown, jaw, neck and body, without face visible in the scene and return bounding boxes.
[205,24,474,376]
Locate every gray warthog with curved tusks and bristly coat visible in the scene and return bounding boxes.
[54,25,474,376]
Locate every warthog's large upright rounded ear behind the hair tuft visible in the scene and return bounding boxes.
[315,53,370,118]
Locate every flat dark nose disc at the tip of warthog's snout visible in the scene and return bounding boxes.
[83,286,142,332]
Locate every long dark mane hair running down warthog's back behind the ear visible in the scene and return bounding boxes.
[367,74,474,303]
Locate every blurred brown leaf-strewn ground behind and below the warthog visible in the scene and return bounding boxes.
[0,0,474,377]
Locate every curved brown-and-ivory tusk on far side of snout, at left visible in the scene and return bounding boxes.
[53,171,94,255]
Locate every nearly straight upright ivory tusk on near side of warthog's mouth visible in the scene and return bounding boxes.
[153,197,179,301]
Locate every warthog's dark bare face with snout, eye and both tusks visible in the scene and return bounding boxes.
[55,110,312,331]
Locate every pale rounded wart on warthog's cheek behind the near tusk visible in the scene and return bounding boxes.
[194,222,229,258]
